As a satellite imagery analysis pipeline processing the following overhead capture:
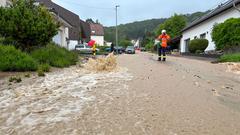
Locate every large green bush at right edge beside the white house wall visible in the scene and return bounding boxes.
[212,18,240,50]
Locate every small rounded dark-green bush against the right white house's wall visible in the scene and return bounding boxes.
[189,39,208,53]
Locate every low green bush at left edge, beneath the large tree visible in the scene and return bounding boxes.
[0,45,38,71]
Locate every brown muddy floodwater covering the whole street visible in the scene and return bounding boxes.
[0,53,240,135]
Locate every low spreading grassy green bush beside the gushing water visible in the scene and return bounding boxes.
[31,43,78,68]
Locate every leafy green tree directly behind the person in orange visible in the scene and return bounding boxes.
[156,14,187,38]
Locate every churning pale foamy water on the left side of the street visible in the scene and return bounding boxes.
[0,62,131,134]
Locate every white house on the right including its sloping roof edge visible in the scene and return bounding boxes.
[180,0,240,53]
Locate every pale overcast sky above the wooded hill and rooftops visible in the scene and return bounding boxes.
[52,0,224,26]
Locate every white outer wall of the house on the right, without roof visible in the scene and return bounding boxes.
[180,6,240,53]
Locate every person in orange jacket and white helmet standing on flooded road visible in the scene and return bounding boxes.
[158,30,170,61]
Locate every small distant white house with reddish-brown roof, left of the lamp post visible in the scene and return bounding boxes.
[90,23,104,46]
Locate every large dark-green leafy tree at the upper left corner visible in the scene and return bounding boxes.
[0,0,59,51]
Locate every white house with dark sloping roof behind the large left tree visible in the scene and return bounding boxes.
[35,0,81,50]
